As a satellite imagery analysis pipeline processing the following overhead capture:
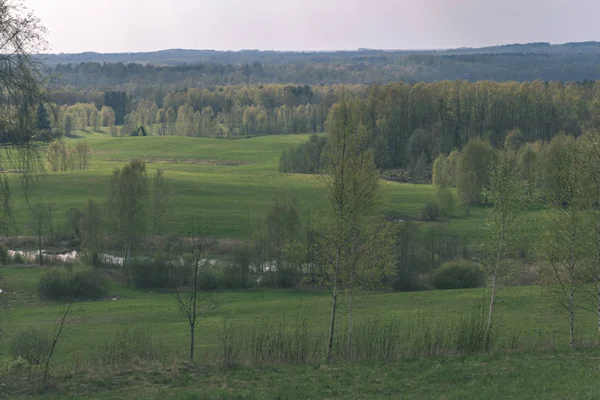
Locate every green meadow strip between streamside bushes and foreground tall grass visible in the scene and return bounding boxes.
[0,266,596,364]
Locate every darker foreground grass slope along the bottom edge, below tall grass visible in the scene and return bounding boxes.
[7,352,600,400]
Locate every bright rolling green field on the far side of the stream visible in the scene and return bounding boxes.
[5,132,486,239]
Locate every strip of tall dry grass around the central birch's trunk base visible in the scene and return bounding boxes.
[217,303,520,365]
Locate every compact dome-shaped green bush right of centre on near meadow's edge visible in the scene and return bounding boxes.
[431,260,485,290]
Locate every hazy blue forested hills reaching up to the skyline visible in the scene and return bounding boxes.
[40,42,600,88]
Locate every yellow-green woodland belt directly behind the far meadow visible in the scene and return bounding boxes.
[45,80,600,176]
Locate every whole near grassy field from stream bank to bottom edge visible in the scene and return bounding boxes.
[0,266,600,399]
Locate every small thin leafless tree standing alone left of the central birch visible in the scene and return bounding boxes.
[174,216,216,361]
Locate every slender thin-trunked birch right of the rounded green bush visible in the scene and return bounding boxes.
[482,144,527,334]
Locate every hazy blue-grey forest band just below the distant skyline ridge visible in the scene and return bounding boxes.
[49,53,600,90]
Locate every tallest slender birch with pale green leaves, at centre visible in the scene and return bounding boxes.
[319,101,379,362]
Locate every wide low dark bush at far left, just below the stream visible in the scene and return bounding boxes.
[38,268,108,300]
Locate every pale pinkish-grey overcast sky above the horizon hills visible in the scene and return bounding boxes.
[23,0,600,53]
